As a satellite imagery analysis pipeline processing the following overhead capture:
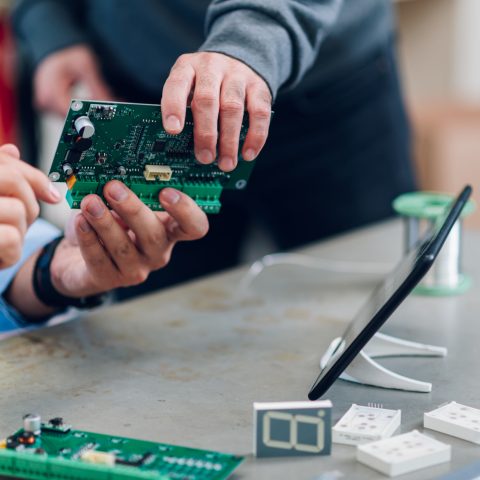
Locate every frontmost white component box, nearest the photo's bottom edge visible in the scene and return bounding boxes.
[357,430,452,477]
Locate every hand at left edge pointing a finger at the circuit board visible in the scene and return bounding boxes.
[0,145,60,269]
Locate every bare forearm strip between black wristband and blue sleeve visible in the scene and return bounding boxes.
[4,251,55,319]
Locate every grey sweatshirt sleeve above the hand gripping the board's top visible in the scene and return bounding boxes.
[200,0,343,96]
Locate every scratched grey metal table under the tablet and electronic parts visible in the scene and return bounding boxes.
[0,222,480,480]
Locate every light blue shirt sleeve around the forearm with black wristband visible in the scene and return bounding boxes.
[0,220,60,334]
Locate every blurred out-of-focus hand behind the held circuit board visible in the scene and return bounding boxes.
[33,45,112,116]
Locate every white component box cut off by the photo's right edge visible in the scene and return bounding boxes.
[423,402,480,445]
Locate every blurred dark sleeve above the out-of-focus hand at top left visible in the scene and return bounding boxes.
[12,0,87,65]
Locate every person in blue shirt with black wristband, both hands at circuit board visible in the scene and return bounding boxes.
[0,141,208,333]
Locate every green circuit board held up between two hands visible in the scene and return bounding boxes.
[49,100,254,213]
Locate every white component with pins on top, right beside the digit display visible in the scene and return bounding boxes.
[332,403,402,445]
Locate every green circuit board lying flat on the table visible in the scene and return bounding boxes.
[0,418,243,480]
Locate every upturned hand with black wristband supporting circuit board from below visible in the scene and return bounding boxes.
[51,181,208,298]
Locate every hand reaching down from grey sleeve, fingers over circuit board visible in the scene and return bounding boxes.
[162,52,272,171]
